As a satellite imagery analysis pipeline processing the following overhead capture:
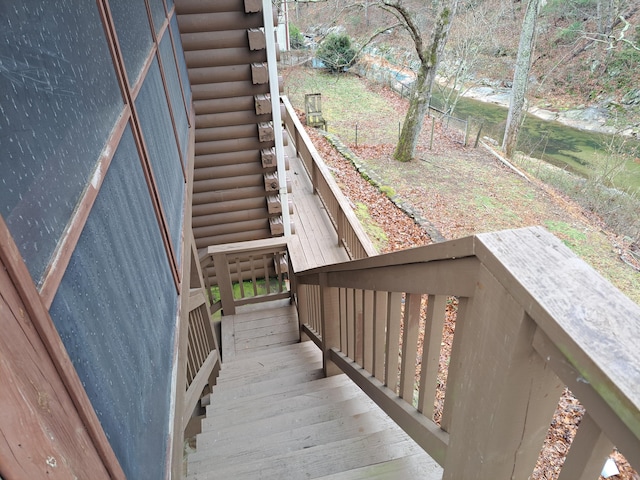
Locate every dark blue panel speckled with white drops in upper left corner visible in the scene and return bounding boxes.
[0,0,123,284]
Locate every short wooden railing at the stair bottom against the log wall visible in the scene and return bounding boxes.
[200,237,292,315]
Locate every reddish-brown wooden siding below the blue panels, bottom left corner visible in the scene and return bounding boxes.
[0,217,125,480]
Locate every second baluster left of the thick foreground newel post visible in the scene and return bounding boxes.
[400,293,422,405]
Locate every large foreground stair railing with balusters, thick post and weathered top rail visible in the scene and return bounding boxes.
[296,228,640,480]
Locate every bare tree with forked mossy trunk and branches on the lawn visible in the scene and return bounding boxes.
[382,0,458,162]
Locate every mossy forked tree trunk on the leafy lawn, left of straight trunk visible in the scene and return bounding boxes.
[390,0,458,162]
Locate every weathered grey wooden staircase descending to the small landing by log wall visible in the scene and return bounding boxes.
[187,307,442,480]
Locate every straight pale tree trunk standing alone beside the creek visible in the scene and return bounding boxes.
[502,0,540,158]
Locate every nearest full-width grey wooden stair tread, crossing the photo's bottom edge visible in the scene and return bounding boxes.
[188,430,428,480]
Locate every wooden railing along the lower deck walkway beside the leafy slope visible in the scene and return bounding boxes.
[282,97,377,260]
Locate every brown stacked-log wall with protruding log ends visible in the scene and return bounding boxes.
[176,0,281,249]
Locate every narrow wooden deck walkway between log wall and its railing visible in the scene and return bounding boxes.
[286,146,349,270]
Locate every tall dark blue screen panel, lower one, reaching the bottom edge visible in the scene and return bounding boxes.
[50,129,178,479]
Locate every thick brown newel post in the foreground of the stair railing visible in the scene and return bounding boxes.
[443,265,563,480]
